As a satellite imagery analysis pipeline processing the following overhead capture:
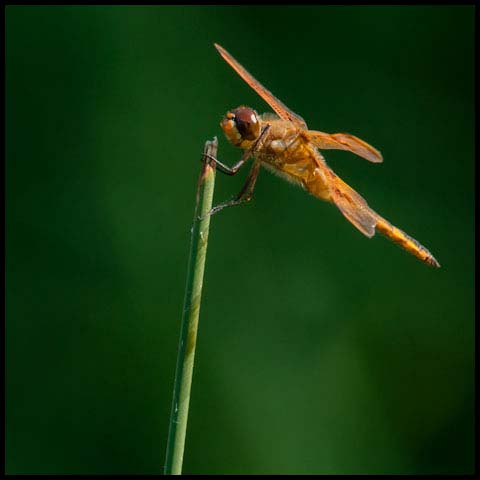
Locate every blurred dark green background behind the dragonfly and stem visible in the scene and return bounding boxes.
[6,6,474,474]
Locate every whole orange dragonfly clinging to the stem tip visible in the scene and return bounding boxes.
[210,44,440,267]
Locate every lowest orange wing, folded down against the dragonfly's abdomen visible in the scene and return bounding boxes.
[329,171,379,237]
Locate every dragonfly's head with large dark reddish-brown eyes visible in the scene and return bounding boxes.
[220,107,261,148]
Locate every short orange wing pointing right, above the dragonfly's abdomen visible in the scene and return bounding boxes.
[305,130,383,163]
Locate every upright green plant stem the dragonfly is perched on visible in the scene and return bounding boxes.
[164,138,218,475]
